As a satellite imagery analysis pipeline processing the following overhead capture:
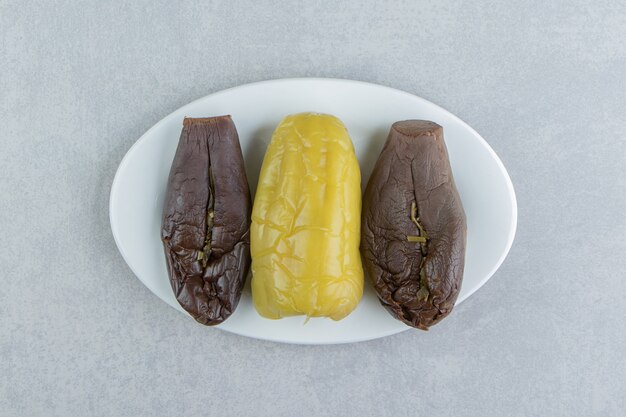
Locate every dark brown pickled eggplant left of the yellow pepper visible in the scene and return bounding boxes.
[161,116,252,326]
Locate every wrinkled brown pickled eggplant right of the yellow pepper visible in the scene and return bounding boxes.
[361,120,467,330]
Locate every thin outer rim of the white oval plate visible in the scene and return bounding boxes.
[109,77,518,345]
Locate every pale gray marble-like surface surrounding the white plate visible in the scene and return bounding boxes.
[0,0,626,417]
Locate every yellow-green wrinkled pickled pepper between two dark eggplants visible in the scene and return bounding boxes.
[251,113,363,320]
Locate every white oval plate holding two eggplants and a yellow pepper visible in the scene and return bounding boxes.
[109,78,517,344]
